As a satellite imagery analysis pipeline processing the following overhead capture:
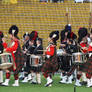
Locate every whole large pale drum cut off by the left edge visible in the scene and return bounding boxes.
[0,53,13,69]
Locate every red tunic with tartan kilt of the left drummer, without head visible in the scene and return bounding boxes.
[4,39,26,74]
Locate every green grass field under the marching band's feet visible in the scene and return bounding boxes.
[0,76,92,92]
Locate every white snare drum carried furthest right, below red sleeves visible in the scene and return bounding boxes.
[72,52,85,63]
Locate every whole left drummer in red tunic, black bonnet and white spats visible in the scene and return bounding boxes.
[2,25,26,86]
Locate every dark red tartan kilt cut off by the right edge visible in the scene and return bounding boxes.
[83,56,92,74]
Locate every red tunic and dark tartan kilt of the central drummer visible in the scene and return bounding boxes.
[42,43,58,74]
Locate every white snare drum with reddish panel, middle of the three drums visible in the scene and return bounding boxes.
[30,55,42,67]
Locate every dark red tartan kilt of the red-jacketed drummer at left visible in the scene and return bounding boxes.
[8,51,27,74]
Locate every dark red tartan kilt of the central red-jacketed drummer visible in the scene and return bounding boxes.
[42,55,58,74]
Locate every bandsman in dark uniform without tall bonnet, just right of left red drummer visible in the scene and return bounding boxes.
[22,32,31,83]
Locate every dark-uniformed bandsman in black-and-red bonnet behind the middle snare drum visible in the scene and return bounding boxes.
[22,31,38,83]
